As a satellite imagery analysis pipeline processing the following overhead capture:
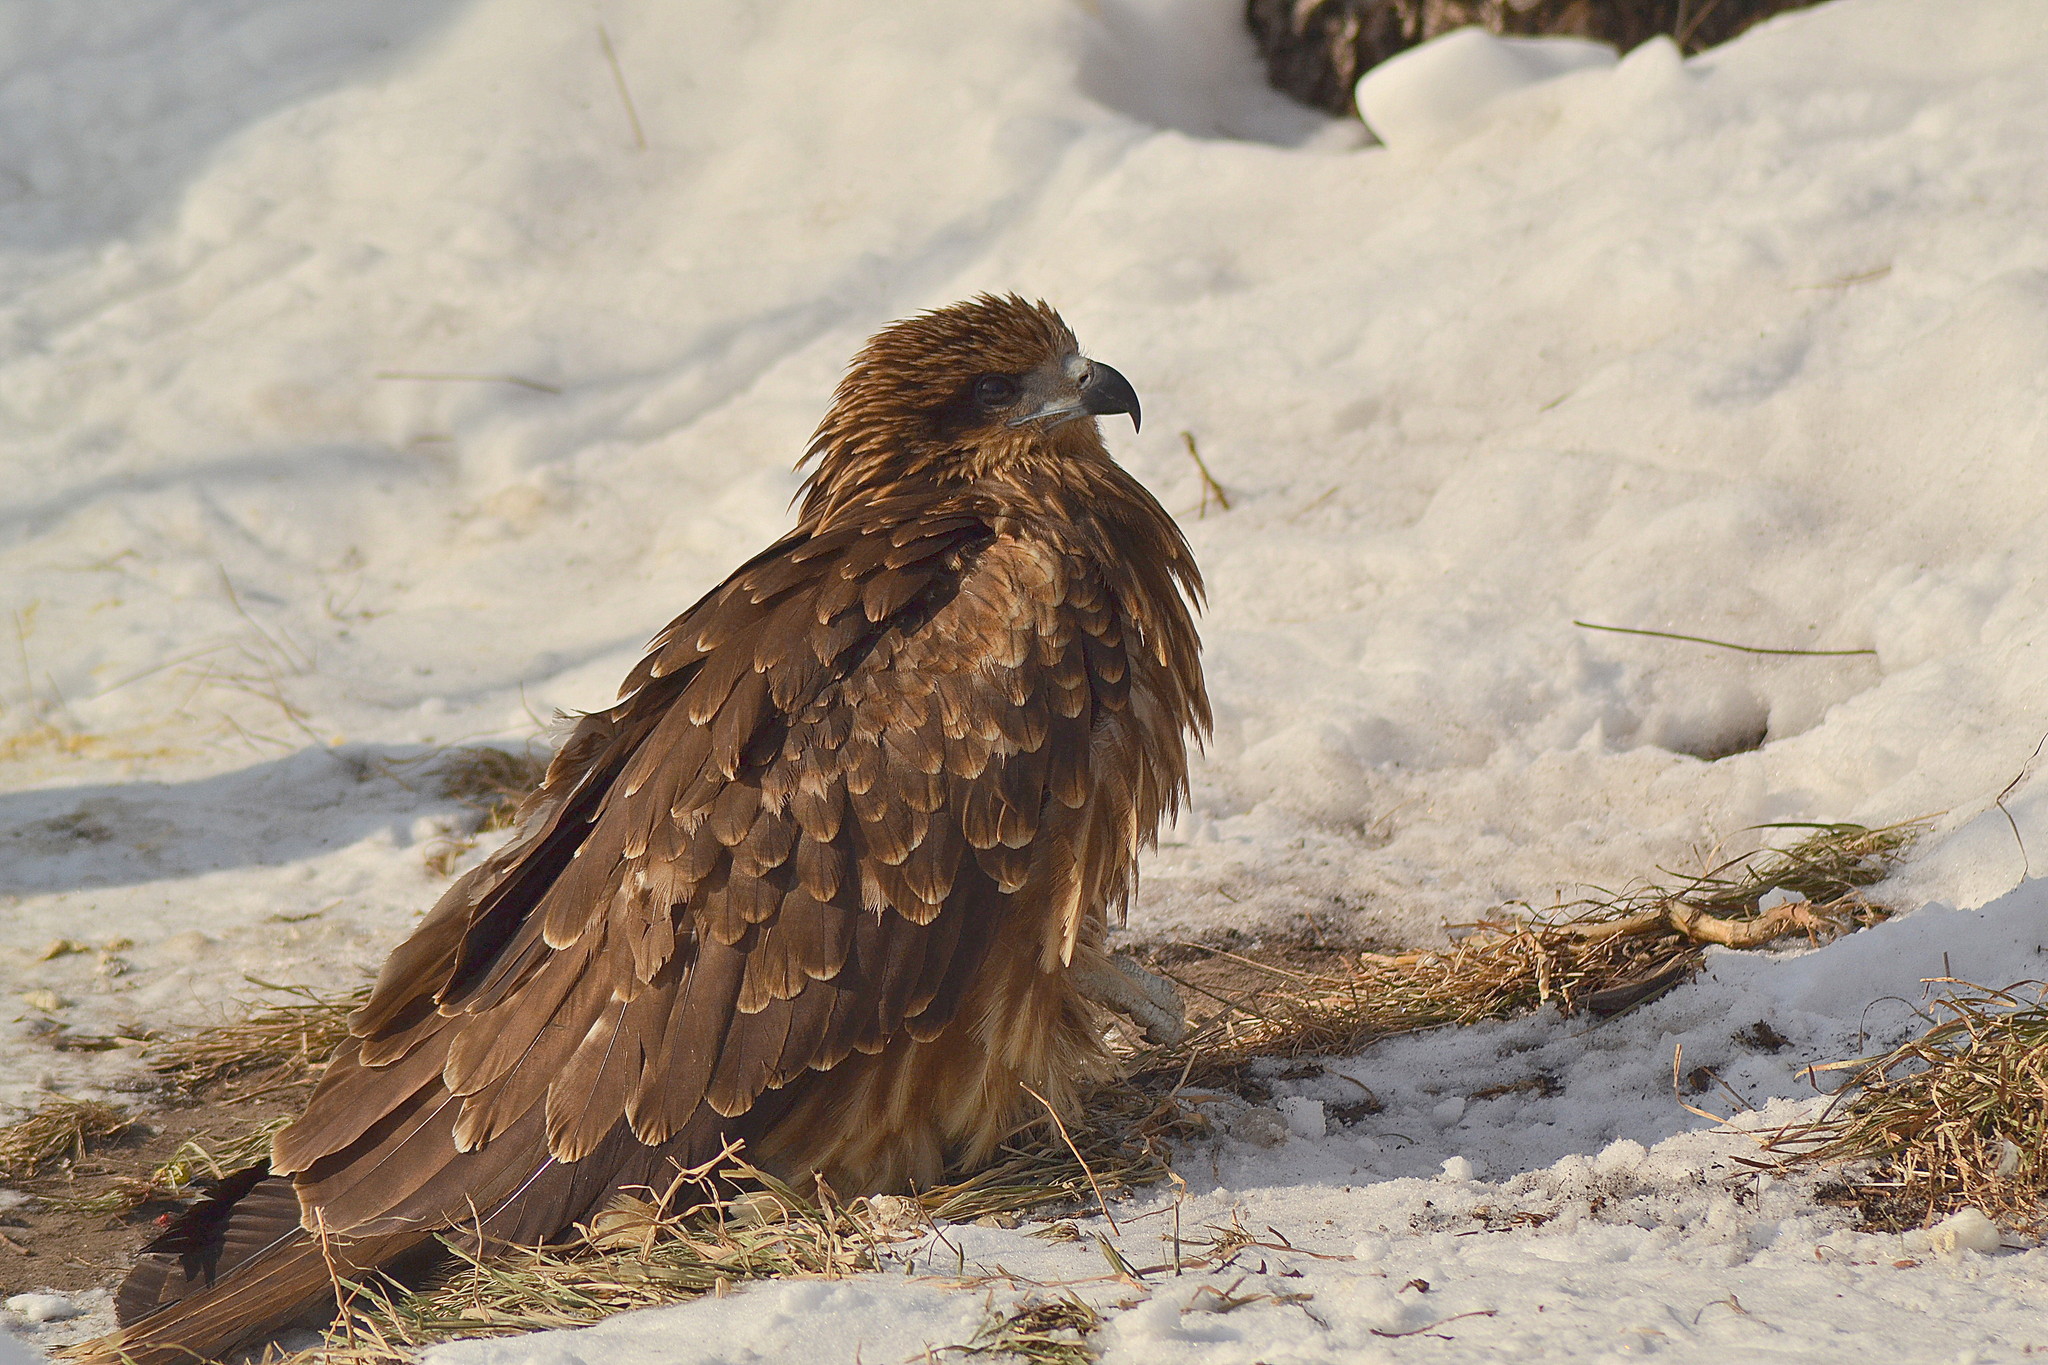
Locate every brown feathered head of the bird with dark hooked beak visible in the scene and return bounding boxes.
[803,295,1139,518]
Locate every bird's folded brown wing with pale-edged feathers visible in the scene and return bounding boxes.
[274,501,1143,1232]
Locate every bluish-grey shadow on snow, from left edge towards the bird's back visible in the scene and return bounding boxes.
[0,745,457,896]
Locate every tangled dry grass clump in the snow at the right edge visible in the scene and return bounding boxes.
[1765,982,2048,1234]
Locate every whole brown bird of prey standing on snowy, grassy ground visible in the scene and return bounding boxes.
[96,295,1208,1365]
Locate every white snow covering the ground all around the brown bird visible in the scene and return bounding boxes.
[0,0,2048,1365]
